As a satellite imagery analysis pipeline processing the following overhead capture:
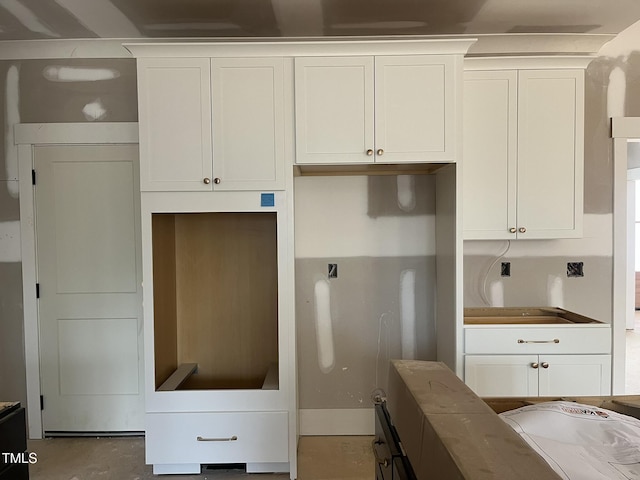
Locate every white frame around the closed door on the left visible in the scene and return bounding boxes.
[14,122,138,438]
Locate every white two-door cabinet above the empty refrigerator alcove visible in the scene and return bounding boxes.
[295,55,459,164]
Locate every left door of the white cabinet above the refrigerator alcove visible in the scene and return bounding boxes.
[295,57,374,164]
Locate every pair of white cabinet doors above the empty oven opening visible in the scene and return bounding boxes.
[138,57,286,191]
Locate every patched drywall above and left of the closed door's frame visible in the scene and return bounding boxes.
[0,59,137,408]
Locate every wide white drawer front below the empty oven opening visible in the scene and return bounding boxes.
[145,412,289,465]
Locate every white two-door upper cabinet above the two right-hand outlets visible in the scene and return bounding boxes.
[463,69,584,239]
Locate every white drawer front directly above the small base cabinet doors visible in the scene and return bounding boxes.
[464,326,611,354]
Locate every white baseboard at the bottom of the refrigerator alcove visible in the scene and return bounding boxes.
[300,408,375,436]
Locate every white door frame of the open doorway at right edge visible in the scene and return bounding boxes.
[611,117,640,395]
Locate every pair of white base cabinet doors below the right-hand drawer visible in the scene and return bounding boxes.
[465,355,611,397]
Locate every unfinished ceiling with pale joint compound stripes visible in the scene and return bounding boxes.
[0,0,640,41]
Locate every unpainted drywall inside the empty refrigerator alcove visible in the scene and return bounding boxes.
[295,175,436,410]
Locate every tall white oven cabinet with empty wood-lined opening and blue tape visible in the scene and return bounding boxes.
[129,45,297,478]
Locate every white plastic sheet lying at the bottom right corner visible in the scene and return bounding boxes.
[500,401,640,480]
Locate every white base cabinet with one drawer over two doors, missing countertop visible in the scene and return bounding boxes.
[464,324,611,397]
